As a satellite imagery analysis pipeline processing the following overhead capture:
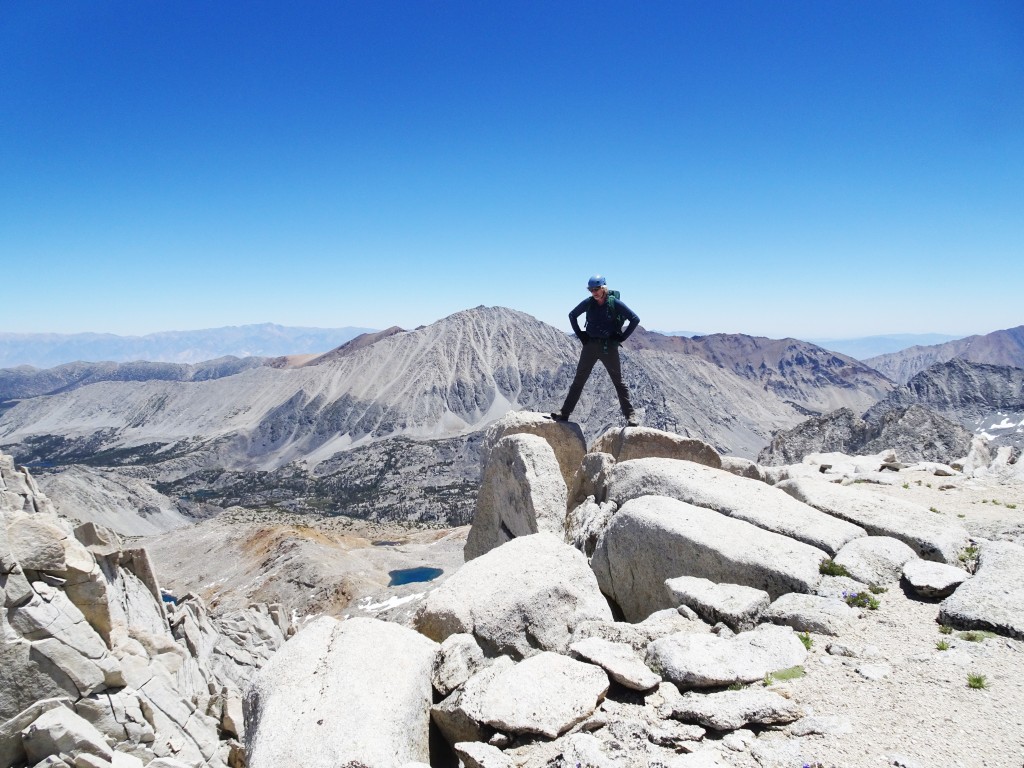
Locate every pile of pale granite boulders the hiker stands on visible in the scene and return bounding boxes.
[245,413,1024,768]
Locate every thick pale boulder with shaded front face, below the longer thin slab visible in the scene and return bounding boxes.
[592,496,826,622]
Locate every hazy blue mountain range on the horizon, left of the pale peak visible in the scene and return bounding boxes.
[0,323,371,368]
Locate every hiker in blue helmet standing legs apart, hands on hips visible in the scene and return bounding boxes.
[551,274,640,427]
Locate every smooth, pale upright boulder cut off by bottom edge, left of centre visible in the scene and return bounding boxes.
[245,616,437,768]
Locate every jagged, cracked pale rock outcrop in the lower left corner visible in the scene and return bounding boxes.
[0,455,289,768]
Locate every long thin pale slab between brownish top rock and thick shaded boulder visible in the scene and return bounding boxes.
[606,459,865,555]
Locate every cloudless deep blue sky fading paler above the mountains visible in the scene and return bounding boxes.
[0,0,1024,338]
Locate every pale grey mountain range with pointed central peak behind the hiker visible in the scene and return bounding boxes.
[0,307,1024,523]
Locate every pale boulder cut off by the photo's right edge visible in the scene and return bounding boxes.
[939,541,1024,640]
